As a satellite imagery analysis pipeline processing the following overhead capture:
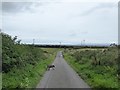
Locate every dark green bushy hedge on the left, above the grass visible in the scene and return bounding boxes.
[2,33,45,73]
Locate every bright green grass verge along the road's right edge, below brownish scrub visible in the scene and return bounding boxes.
[64,49,118,89]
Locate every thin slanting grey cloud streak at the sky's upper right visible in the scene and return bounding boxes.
[79,3,117,16]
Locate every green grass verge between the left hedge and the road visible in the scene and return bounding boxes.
[3,50,55,88]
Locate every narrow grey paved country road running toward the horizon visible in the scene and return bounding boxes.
[36,51,90,88]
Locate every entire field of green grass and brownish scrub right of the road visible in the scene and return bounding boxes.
[63,47,120,89]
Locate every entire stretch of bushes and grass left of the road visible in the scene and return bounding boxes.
[2,33,58,88]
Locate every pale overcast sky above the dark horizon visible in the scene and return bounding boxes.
[0,0,118,45]
